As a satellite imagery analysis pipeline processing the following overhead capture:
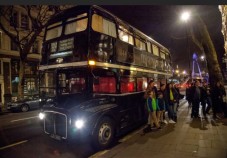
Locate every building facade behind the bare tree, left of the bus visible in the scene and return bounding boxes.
[0,6,42,105]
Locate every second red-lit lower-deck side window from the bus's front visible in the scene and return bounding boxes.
[121,77,135,93]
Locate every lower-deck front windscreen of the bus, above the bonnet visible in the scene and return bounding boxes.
[40,70,86,97]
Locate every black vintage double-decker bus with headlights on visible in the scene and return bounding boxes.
[39,6,172,149]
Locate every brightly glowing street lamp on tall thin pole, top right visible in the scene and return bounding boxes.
[180,11,192,78]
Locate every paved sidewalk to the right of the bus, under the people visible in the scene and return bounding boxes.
[94,101,227,158]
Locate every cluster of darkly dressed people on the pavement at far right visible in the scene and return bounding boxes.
[186,80,227,119]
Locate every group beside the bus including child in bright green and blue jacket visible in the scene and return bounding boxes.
[144,80,180,131]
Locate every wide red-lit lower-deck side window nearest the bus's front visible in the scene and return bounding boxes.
[93,77,116,93]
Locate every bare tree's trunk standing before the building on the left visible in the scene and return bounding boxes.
[18,60,25,99]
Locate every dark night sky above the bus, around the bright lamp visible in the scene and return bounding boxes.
[101,5,224,69]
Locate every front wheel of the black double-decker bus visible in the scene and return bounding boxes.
[92,117,115,150]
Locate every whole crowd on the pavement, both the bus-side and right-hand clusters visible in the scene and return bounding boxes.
[144,80,227,132]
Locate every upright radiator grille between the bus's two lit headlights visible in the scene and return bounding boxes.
[44,111,67,139]
